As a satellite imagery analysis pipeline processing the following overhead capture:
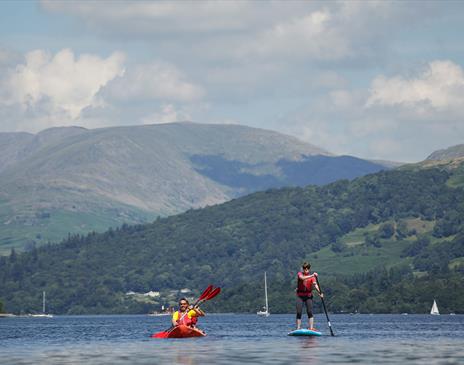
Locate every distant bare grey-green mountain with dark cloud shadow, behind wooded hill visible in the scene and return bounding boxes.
[0,122,394,250]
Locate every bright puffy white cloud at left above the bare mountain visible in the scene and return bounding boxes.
[0,49,124,118]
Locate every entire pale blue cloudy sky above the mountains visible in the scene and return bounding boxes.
[0,0,464,162]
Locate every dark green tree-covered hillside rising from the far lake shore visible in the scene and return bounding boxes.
[0,165,464,314]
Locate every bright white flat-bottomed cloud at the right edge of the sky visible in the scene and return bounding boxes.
[366,61,464,112]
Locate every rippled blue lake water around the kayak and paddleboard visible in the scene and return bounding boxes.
[0,314,464,365]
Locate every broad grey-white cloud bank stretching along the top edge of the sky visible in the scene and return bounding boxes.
[41,0,406,62]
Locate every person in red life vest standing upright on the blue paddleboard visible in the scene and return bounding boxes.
[296,262,324,331]
